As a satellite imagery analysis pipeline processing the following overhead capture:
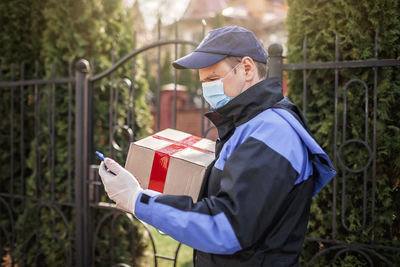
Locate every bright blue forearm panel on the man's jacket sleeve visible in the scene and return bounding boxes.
[135,190,242,254]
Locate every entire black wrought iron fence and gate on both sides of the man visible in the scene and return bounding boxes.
[0,22,400,266]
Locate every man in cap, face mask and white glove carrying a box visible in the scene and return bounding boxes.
[99,26,335,267]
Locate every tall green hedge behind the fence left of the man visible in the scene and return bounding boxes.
[0,0,152,266]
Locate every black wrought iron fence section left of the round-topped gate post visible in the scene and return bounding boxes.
[0,61,75,266]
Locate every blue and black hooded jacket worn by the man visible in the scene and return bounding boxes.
[135,78,335,267]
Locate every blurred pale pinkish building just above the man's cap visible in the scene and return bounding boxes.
[172,0,288,53]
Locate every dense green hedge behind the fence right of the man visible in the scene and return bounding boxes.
[287,0,400,266]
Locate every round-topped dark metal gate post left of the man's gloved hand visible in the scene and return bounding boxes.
[75,59,90,267]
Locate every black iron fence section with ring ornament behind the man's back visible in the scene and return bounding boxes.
[269,34,400,266]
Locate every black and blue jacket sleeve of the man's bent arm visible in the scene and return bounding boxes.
[135,136,304,254]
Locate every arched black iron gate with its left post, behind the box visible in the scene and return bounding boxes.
[75,19,207,266]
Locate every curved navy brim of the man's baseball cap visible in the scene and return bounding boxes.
[172,52,227,69]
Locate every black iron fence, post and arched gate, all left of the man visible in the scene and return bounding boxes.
[0,19,209,266]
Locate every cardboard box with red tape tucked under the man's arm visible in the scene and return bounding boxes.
[125,129,215,202]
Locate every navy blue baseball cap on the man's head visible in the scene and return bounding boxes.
[172,26,267,69]
